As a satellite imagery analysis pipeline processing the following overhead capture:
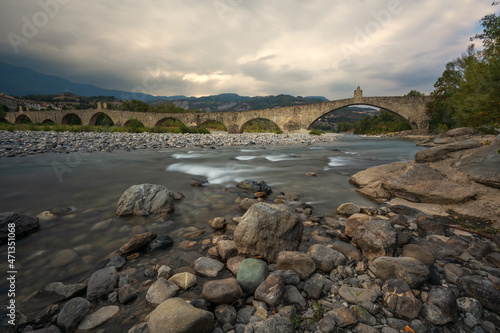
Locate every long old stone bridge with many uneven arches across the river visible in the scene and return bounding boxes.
[6,87,431,133]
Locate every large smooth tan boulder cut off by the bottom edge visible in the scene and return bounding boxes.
[148,298,214,333]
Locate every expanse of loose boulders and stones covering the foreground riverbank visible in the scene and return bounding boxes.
[0,174,500,333]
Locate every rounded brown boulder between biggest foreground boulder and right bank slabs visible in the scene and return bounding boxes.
[352,220,397,260]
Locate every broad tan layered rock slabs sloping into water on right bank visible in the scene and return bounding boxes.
[350,130,500,227]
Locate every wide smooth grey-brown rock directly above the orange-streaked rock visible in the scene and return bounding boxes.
[373,257,430,288]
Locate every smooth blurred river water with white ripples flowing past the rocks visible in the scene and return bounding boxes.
[0,135,421,322]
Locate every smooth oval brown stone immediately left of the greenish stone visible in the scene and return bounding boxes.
[202,278,243,304]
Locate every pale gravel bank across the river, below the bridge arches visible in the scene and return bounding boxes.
[0,131,336,157]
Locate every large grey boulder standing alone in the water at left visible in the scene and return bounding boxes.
[116,184,174,216]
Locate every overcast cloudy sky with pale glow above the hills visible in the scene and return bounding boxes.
[0,0,499,99]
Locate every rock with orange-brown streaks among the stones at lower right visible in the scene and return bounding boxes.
[382,279,422,319]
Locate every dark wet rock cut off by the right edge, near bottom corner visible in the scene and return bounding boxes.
[458,276,500,313]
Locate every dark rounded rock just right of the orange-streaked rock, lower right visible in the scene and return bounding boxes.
[425,286,458,325]
